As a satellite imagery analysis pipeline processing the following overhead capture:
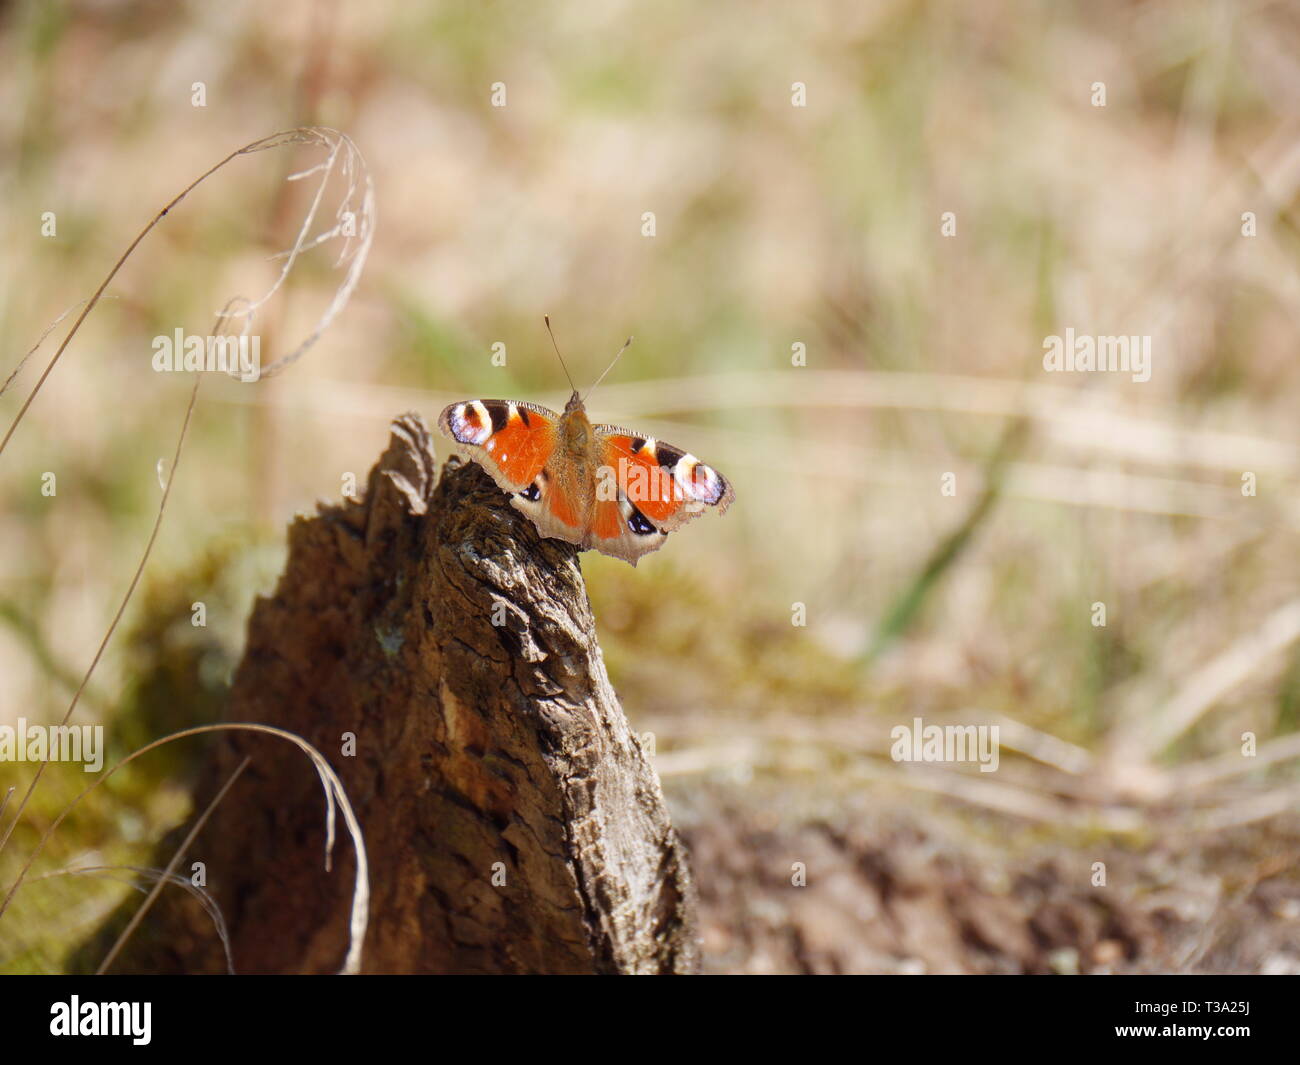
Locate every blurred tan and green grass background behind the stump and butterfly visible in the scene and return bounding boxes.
[0,0,1300,971]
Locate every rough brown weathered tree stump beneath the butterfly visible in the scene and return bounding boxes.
[100,415,698,973]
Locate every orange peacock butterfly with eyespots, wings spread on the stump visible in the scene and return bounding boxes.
[438,319,736,566]
